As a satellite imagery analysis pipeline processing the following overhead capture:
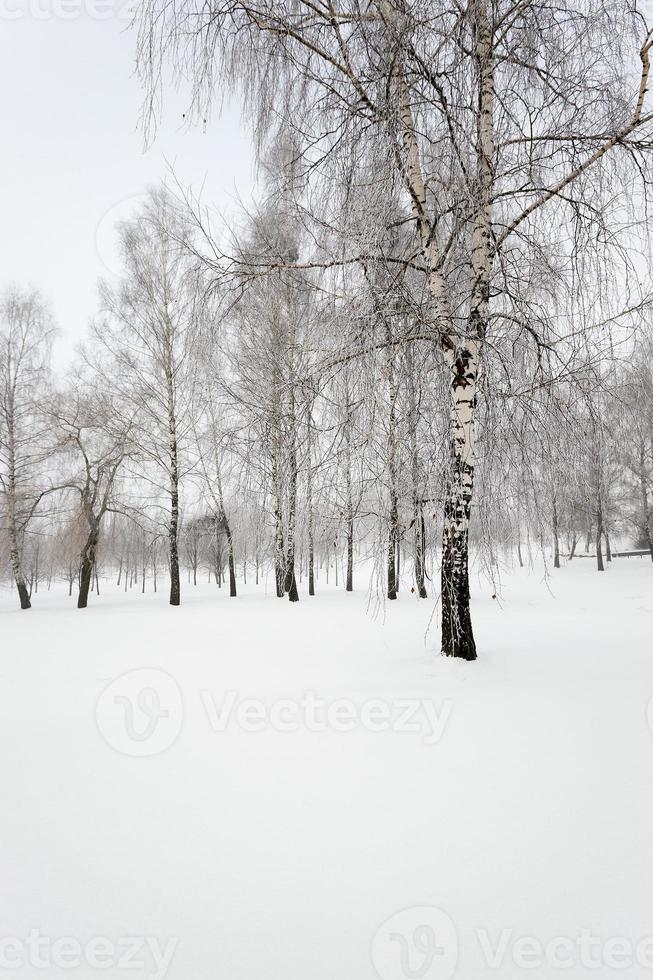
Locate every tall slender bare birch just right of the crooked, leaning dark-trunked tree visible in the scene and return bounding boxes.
[94,190,198,606]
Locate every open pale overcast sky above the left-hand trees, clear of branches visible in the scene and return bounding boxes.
[0,0,253,364]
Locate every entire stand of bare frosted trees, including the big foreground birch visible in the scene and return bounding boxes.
[2,0,653,660]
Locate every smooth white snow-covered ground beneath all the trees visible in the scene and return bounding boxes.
[0,559,653,980]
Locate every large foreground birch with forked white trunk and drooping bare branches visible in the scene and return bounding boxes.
[139,0,653,660]
